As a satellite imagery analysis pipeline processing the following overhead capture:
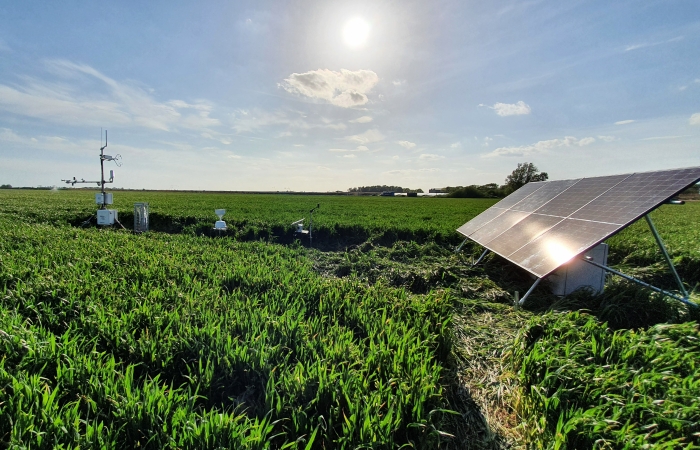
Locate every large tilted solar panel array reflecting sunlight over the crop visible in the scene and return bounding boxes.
[457,167,700,278]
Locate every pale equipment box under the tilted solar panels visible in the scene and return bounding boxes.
[549,243,608,295]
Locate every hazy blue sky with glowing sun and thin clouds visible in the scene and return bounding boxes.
[0,0,700,191]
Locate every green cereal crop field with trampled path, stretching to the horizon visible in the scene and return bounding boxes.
[0,190,700,449]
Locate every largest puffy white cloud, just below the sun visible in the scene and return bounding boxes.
[279,69,379,108]
